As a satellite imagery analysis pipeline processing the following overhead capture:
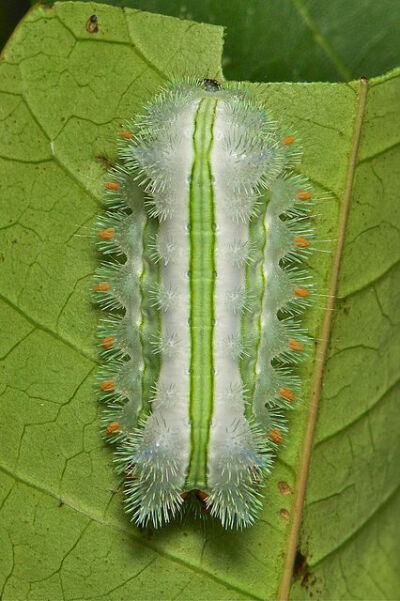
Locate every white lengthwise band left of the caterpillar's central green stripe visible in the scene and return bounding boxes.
[137,102,198,517]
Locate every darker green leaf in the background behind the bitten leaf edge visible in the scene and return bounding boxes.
[31,0,400,81]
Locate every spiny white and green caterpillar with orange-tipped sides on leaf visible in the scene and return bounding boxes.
[93,79,313,529]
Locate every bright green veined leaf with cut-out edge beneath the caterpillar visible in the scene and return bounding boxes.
[0,2,400,601]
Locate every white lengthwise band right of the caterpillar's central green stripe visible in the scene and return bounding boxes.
[208,101,266,525]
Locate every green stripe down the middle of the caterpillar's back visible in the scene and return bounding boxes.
[186,98,217,489]
